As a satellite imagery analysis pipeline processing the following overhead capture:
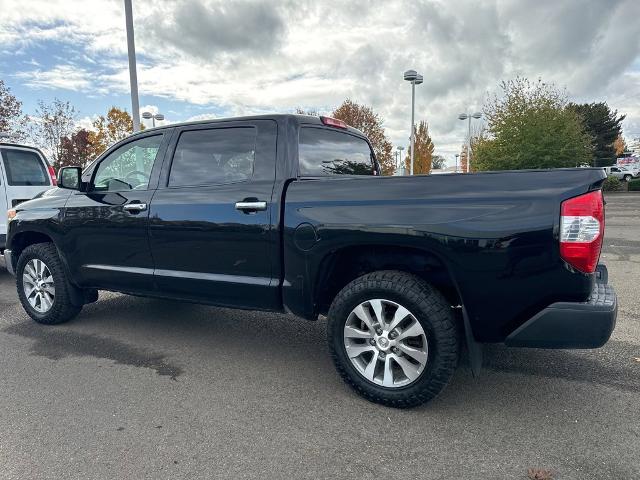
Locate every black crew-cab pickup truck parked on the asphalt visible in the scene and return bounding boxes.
[5,115,617,407]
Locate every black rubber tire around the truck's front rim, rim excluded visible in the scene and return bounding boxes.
[16,243,82,325]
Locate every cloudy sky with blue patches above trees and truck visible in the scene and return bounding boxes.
[0,0,640,165]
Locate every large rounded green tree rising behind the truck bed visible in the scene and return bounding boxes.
[471,78,592,170]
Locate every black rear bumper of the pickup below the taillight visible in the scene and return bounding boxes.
[505,277,618,348]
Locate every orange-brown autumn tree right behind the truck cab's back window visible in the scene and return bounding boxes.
[331,98,396,175]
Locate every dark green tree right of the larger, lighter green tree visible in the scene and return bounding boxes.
[568,102,625,167]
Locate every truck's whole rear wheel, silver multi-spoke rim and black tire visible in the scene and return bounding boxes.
[328,271,459,408]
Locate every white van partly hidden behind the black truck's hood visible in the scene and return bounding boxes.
[0,142,57,254]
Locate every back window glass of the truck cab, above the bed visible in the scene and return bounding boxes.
[298,127,376,176]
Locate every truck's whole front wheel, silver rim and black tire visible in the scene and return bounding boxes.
[16,243,82,325]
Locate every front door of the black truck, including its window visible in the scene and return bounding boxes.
[62,132,169,293]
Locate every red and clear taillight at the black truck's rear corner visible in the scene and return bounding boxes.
[560,190,604,273]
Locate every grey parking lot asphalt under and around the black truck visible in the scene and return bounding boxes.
[0,194,640,479]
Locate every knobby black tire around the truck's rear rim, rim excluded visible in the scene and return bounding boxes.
[327,270,459,408]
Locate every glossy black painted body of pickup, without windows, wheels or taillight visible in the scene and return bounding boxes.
[7,115,615,345]
